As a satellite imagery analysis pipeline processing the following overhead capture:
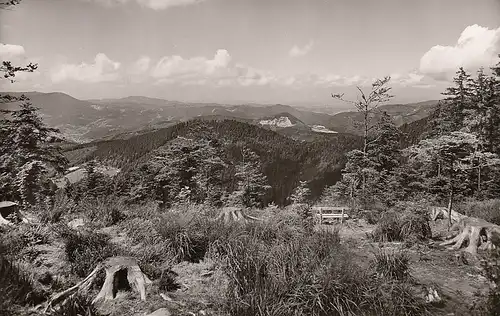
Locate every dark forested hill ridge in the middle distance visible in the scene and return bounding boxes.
[66,120,361,205]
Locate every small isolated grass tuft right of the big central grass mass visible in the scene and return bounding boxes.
[373,249,410,281]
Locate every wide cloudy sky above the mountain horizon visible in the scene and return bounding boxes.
[0,0,500,105]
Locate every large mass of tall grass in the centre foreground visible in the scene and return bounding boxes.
[218,215,427,316]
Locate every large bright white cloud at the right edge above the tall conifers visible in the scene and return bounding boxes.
[420,24,500,80]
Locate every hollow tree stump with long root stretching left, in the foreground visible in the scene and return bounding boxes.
[45,257,151,312]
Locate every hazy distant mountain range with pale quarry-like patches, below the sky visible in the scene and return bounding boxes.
[0,92,437,142]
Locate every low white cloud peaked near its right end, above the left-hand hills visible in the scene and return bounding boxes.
[51,53,120,83]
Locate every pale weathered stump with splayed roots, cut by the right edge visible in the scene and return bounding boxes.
[441,214,500,255]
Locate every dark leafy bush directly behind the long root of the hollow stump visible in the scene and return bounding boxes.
[60,228,120,277]
